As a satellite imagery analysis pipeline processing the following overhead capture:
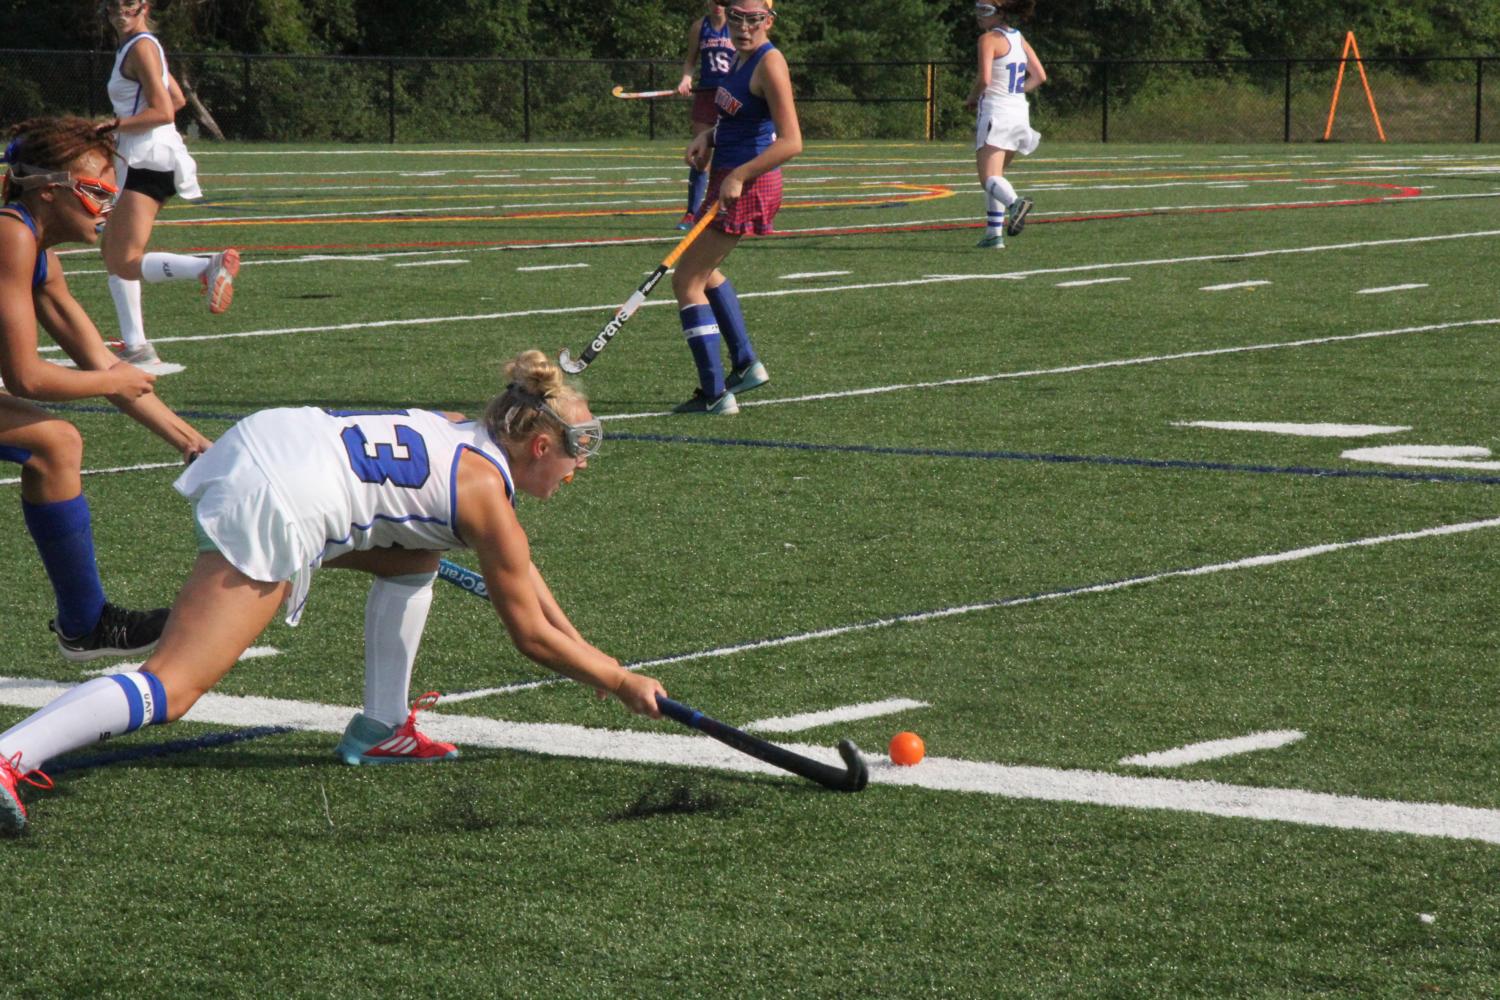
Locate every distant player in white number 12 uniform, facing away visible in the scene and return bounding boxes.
[968,0,1047,249]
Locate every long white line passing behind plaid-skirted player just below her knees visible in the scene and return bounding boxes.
[41,229,1500,359]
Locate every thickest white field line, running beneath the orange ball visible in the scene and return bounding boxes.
[0,678,1500,844]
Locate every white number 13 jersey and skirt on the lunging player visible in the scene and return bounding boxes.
[176,406,515,621]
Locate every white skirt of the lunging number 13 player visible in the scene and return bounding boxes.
[173,426,324,625]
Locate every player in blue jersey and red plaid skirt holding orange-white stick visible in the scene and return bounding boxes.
[672,0,803,415]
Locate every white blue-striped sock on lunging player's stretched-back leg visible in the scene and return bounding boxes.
[0,670,167,771]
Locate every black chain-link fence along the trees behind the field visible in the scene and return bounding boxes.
[0,49,1500,142]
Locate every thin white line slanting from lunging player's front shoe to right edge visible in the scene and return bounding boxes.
[443,517,1500,702]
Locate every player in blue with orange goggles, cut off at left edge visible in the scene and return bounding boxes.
[0,118,209,663]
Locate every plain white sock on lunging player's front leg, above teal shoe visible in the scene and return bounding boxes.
[365,573,438,726]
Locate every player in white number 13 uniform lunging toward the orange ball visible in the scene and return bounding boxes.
[0,351,666,831]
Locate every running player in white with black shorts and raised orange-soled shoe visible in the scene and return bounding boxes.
[104,0,240,373]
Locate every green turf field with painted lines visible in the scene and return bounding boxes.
[0,142,1500,999]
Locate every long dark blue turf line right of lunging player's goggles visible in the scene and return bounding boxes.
[608,432,1500,486]
